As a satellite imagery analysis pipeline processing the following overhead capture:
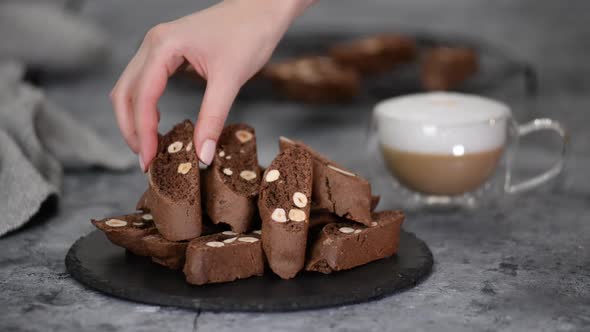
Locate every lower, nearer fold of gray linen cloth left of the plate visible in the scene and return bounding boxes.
[0,61,135,236]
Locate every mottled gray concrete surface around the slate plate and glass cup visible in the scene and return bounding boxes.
[0,0,590,332]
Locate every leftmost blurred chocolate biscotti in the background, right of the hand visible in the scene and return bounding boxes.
[262,56,360,103]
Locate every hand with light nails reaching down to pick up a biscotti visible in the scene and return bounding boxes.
[111,0,312,172]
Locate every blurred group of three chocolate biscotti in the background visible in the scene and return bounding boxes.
[261,33,479,103]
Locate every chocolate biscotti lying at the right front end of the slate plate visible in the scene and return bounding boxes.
[305,211,404,274]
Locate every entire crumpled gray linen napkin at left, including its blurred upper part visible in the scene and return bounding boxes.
[0,0,136,236]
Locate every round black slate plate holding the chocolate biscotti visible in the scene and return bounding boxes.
[66,230,433,312]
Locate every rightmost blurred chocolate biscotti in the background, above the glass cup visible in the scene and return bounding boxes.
[421,47,478,90]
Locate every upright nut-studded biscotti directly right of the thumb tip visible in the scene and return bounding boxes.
[204,124,260,233]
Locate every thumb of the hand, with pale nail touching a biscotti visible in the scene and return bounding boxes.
[194,75,240,165]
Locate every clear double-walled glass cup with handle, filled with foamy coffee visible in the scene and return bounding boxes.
[368,92,568,208]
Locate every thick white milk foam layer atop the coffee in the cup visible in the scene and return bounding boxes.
[374,92,510,155]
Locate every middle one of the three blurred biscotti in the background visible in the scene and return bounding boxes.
[330,35,416,74]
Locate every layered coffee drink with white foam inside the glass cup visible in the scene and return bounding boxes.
[375,93,510,196]
